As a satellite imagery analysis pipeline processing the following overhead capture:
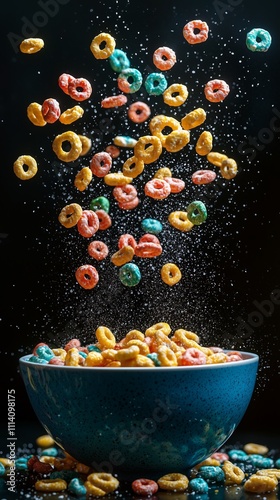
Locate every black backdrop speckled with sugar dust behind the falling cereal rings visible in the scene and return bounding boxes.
[0,0,280,442]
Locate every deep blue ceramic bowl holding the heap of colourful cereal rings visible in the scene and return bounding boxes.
[20,353,259,479]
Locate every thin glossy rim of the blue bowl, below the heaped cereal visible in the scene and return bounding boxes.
[19,349,259,373]
